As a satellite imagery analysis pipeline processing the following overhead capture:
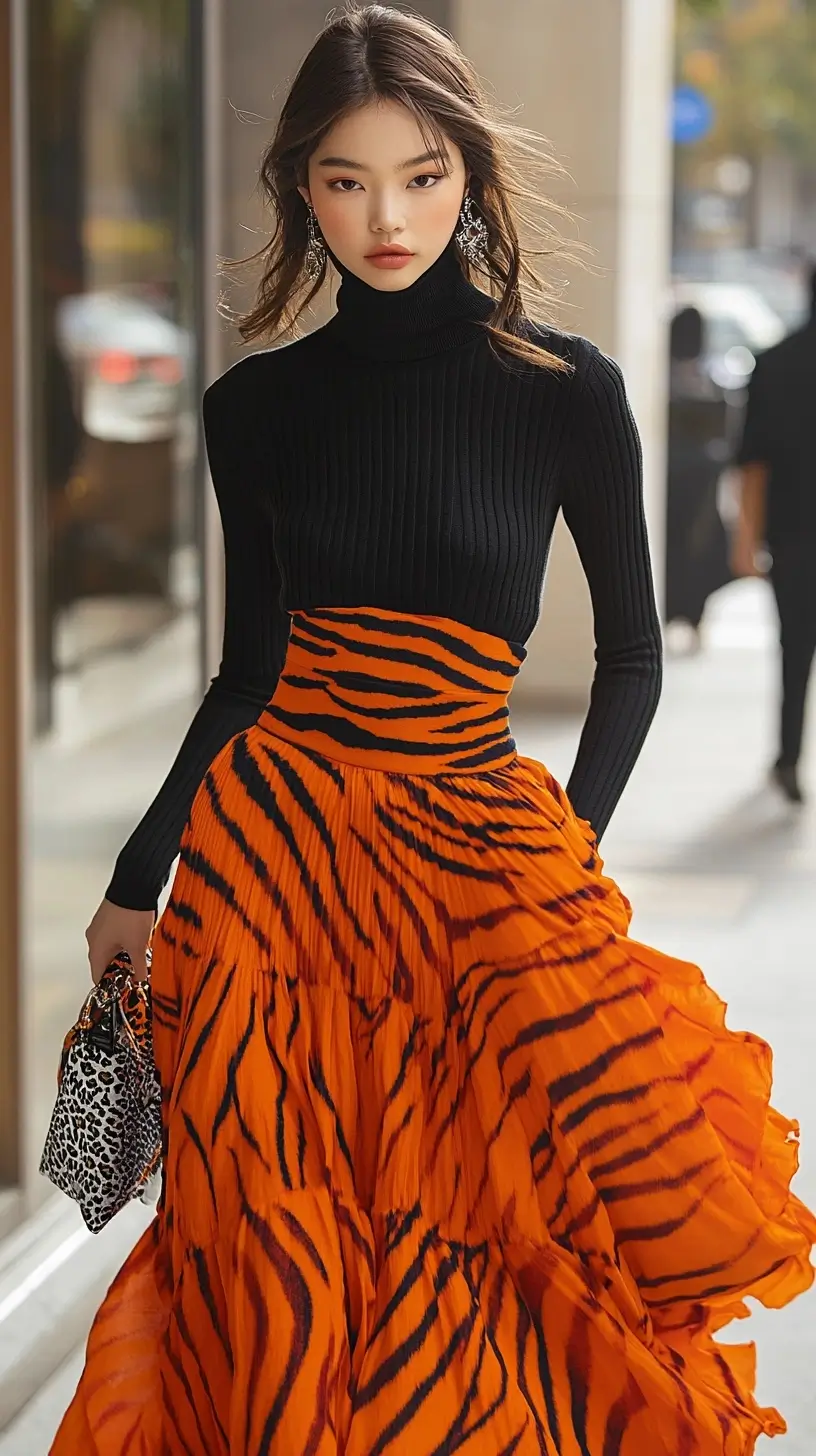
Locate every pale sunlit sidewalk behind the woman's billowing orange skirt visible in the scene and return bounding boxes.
[0,582,816,1456]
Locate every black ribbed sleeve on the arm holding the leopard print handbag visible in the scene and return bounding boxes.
[106,360,289,910]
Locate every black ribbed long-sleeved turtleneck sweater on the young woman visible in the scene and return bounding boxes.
[106,246,660,909]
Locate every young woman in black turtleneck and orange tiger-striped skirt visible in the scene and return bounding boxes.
[52,6,816,1456]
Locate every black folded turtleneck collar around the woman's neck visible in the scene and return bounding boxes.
[329,242,495,360]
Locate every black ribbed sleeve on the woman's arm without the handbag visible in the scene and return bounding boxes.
[561,349,662,839]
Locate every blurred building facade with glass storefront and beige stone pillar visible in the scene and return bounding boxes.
[0,0,672,1425]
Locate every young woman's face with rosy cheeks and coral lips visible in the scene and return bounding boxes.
[300,102,466,293]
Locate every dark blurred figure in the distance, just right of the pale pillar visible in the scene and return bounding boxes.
[666,307,731,646]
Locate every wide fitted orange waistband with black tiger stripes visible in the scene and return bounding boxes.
[258,607,525,775]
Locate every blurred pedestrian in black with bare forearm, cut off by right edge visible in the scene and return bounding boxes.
[731,268,816,804]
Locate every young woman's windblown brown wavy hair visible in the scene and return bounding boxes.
[227,3,568,370]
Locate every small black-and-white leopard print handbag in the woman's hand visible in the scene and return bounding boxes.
[39,951,162,1233]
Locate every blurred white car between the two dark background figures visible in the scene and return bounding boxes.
[672,278,785,390]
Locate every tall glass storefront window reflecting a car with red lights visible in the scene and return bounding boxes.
[25,0,201,1193]
